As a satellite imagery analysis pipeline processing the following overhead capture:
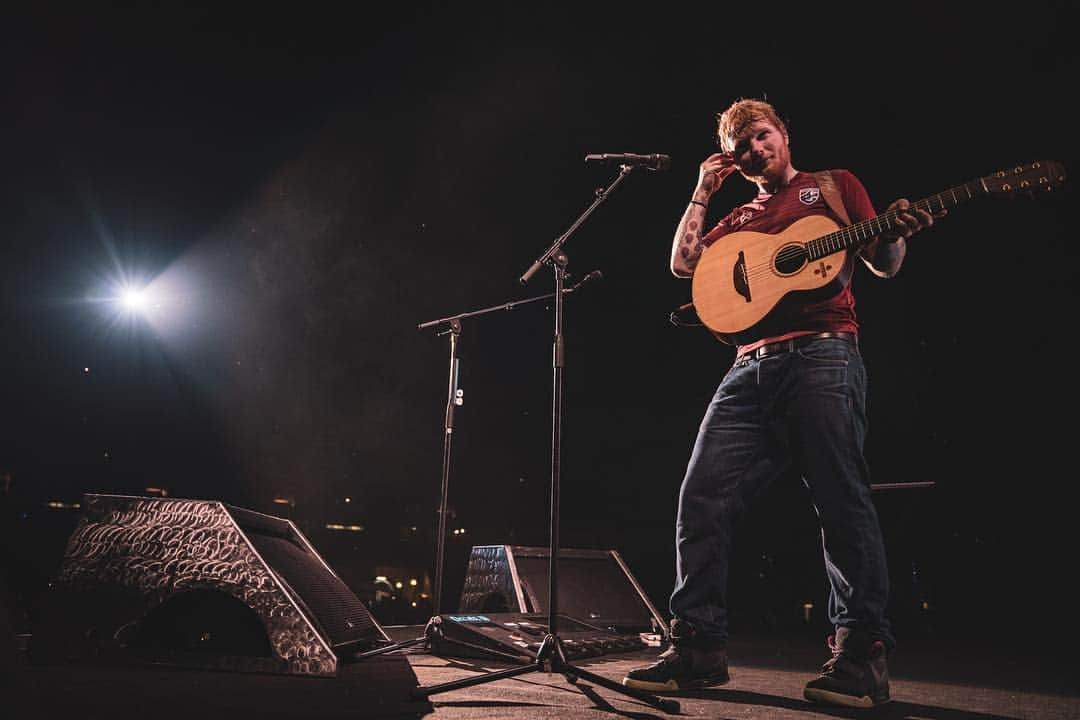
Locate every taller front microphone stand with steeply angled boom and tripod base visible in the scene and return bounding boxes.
[414,163,679,712]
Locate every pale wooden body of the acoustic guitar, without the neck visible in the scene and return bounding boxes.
[691,215,851,341]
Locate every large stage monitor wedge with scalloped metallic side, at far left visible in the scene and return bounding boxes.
[31,494,390,676]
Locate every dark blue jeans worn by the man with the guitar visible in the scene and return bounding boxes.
[670,338,894,649]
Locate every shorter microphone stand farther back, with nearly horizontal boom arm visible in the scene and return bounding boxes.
[353,270,604,660]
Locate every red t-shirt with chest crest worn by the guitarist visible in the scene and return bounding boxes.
[702,169,877,351]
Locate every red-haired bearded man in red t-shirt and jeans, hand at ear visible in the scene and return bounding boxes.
[623,99,944,707]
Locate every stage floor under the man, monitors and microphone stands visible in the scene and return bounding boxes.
[4,626,1080,720]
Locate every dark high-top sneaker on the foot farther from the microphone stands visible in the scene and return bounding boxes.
[802,627,889,708]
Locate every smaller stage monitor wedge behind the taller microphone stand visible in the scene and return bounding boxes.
[460,545,667,636]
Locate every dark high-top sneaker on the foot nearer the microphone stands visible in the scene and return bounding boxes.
[622,620,730,693]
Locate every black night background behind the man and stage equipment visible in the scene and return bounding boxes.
[0,2,1080,660]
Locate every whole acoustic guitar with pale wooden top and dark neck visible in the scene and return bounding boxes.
[691,161,1065,342]
